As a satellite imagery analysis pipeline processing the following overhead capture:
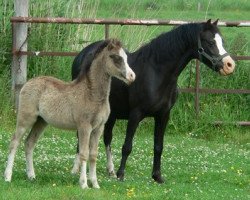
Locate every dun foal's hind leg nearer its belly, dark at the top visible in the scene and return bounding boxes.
[25,117,47,179]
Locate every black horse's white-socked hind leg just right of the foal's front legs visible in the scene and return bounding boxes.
[103,116,116,177]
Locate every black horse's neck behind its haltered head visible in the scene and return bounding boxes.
[147,24,200,76]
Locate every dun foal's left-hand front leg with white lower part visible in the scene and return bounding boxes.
[78,124,92,189]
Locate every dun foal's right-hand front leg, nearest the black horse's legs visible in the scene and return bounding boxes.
[89,124,104,188]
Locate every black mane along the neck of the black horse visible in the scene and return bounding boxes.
[135,23,218,63]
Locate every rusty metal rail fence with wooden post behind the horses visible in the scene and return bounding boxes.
[11,17,250,126]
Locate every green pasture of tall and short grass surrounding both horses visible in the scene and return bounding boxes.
[0,0,250,200]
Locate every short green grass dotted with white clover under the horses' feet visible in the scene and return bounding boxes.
[0,120,250,200]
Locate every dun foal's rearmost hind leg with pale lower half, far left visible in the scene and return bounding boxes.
[4,115,36,182]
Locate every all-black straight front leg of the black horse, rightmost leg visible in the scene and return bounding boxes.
[152,111,170,183]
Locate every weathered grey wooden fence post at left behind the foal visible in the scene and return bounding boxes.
[11,0,29,109]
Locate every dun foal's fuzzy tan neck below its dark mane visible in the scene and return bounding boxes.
[80,56,111,101]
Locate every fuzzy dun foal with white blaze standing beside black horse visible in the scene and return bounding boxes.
[4,39,135,188]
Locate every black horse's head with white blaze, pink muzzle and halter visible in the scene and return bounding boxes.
[198,19,235,75]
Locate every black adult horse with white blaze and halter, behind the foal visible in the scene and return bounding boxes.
[72,20,235,183]
